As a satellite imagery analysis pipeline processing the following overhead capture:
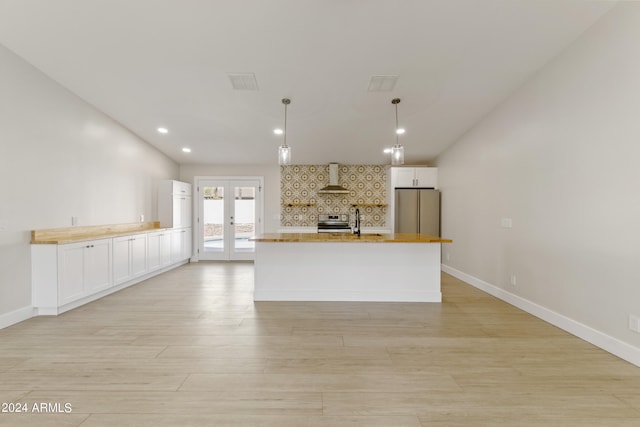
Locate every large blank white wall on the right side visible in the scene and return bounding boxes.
[437,2,640,361]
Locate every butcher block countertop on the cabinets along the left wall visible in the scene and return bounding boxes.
[31,221,164,245]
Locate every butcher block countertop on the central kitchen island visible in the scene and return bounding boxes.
[250,233,451,243]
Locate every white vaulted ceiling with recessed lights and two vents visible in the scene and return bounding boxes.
[0,0,615,164]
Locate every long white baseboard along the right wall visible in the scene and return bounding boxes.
[442,264,640,366]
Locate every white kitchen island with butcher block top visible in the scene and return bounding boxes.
[252,233,451,302]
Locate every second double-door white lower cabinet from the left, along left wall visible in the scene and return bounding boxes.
[113,233,147,285]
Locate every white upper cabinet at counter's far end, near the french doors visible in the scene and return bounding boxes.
[158,180,193,228]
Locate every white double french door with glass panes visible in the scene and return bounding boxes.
[197,178,262,261]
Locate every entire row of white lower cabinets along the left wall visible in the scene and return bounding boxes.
[31,228,192,315]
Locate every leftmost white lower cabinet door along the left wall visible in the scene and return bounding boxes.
[58,242,88,305]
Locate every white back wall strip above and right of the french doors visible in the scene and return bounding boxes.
[180,164,280,233]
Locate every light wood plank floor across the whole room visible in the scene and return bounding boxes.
[0,263,640,427]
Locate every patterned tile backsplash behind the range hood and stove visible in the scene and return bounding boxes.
[280,165,387,231]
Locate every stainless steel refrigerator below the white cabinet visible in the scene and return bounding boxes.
[394,188,440,236]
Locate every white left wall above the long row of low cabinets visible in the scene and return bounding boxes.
[0,46,179,319]
